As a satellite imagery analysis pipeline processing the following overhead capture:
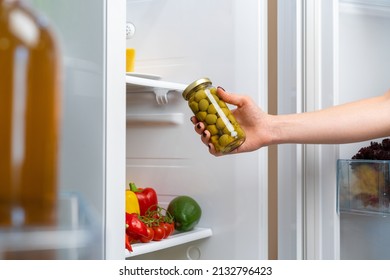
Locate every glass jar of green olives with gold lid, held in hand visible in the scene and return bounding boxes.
[183,78,245,154]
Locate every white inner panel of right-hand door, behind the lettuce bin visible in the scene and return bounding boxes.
[339,1,390,259]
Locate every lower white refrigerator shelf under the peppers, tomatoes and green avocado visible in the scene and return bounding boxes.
[125,228,213,258]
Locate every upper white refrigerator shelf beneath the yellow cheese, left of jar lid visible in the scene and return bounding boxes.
[126,75,187,105]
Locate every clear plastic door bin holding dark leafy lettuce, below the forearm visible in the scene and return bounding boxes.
[337,159,390,216]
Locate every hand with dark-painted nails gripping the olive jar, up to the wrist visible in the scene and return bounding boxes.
[191,87,271,156]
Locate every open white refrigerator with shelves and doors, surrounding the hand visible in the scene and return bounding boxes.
[28,0,390,261]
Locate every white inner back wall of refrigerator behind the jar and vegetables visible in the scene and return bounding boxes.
[126,0,267,259]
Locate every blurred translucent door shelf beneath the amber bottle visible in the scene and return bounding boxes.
[0,192,102,260]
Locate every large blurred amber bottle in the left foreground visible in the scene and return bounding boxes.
[0,0,60,226]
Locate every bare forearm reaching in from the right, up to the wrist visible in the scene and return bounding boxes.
[271,92,390,144]
